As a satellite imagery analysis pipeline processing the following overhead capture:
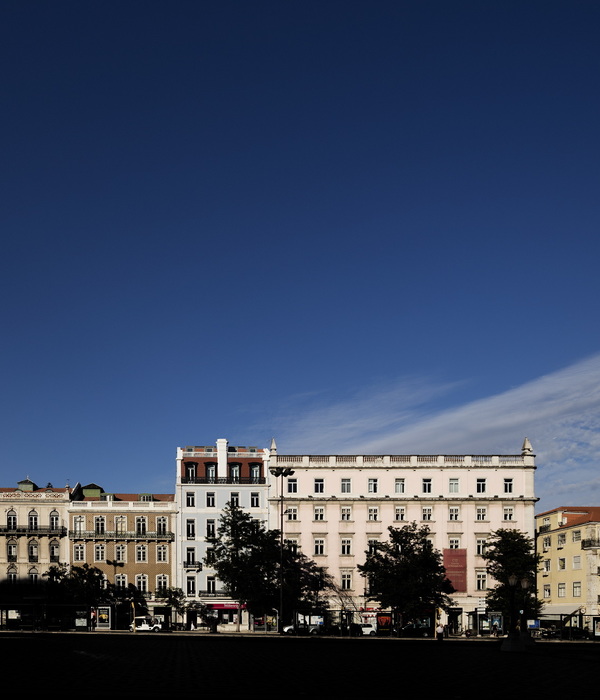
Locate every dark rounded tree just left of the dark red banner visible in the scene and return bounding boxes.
[358,522,454,622]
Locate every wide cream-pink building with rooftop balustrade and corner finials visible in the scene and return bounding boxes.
[269,438,537,633]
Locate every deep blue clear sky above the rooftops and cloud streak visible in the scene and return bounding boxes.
[0,0,600,507]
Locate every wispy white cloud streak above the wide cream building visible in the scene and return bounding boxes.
[270,355,600,510]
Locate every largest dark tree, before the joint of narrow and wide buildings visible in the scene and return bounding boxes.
[205,503,332,615]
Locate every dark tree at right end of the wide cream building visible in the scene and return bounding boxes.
[483,529,543,630]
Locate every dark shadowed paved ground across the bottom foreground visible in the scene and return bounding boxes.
[5,632,600,700]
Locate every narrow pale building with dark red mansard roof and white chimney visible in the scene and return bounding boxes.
[175,439,269,624]
